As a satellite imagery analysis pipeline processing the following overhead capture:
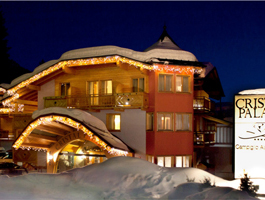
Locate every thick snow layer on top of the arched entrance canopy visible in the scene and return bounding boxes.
[32,107,131,152]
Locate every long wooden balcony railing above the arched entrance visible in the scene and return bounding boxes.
[44,92,148,109]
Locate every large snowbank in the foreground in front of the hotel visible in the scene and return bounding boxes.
[0,157,256,200]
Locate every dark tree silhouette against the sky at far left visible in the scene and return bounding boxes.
[0,6,30,84]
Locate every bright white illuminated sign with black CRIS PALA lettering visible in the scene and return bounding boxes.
[234,94,265,178]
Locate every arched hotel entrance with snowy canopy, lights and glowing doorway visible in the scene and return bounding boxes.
[13,108,131,173]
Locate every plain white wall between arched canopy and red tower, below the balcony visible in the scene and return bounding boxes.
[90,109,146,159]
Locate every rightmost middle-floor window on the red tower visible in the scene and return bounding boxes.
[176,113,192,131]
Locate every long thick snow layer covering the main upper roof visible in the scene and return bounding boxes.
[7,46,198,89]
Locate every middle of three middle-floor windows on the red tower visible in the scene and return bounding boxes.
[157,113,173,131]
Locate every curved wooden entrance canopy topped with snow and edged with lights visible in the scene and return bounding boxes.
[13,107,132,155]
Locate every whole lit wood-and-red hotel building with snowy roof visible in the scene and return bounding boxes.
[0,28,229,173]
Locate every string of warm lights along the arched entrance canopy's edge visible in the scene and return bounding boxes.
[13,116,128,156]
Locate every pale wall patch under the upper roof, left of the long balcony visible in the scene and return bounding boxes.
[38,80,55,110]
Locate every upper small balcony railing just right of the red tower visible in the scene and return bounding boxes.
[193,97,215,112]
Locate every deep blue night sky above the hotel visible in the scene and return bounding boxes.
[0,1,265,101]
